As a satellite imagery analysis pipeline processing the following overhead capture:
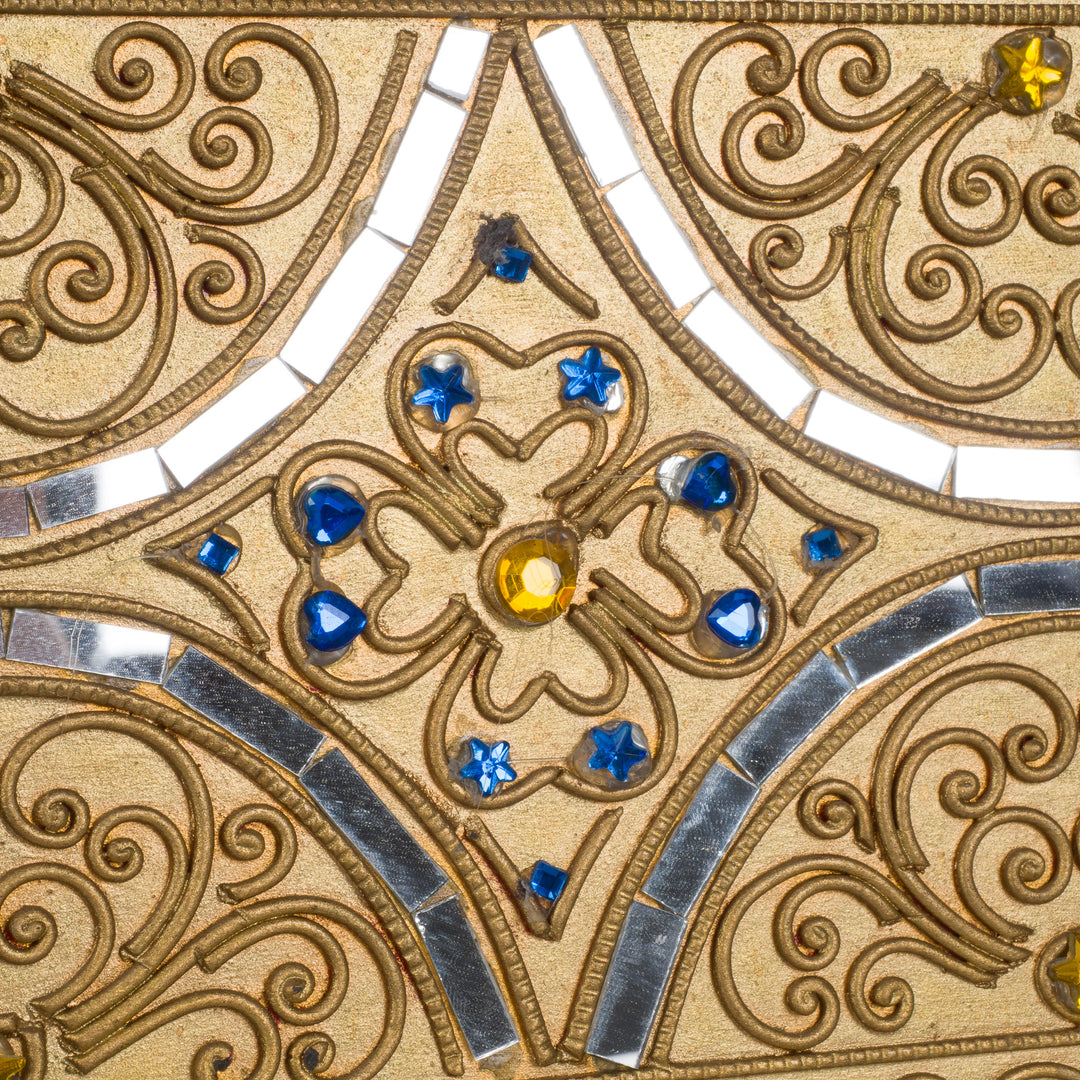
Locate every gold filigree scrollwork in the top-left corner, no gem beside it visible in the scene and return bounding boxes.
[0,22,338,444]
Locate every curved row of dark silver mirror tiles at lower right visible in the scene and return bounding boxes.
[585,559,1080,1068]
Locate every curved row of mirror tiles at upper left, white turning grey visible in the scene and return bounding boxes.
[0,24,491,537]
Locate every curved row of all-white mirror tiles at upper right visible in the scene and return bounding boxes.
[534,25,1080,503]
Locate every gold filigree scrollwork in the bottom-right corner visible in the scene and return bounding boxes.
[713,662,1078,1050]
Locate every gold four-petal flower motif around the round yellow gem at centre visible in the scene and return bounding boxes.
[275,323,785,808]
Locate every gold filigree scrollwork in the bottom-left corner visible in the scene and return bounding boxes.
[0,687,405,1080]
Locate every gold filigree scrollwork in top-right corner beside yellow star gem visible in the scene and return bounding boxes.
[656,24,1077,425]
